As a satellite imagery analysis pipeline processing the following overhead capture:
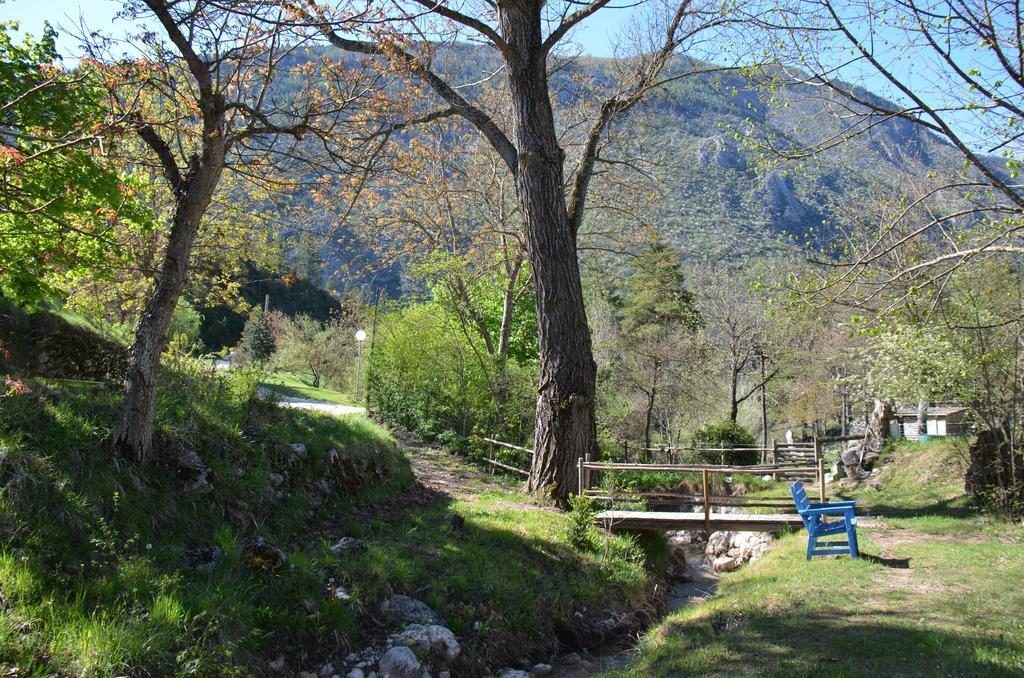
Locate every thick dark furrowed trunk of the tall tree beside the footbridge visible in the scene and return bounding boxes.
[499,6,597,502]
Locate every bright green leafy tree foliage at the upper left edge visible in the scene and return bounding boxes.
[0,22,153,303]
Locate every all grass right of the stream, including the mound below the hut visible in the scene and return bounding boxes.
[624,442,1024,676]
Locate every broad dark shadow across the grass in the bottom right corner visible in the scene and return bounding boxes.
[651,609,1024,676]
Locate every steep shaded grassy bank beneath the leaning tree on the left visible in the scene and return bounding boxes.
[0,362,412,675]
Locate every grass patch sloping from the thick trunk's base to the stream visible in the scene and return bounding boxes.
[325,488,656,675]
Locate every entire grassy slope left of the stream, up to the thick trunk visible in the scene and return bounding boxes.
[0,362,652,675]
